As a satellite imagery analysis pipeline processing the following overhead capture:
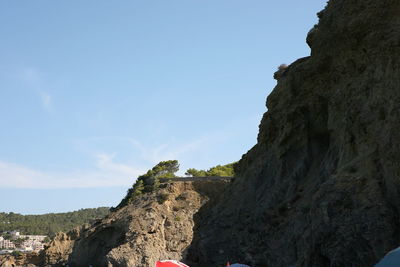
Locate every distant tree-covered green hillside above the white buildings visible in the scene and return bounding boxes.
[0,207,109,237]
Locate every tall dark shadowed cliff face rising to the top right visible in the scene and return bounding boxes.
[188,0,400,267]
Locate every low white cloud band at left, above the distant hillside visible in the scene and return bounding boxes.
[0,154,143,189]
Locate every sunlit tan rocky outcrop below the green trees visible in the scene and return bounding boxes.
[43,180,229,267]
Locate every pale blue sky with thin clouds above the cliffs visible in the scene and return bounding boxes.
[0,0,326,214]
